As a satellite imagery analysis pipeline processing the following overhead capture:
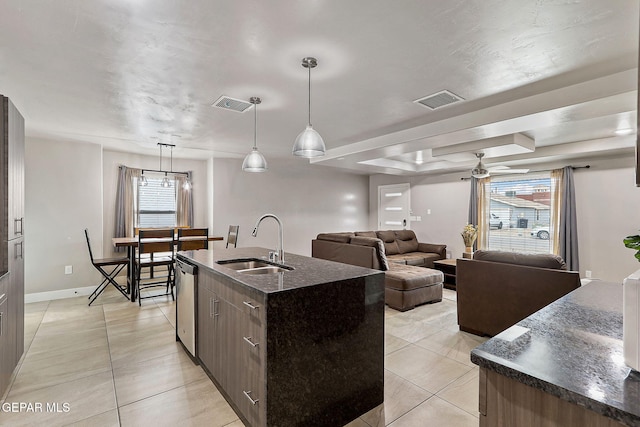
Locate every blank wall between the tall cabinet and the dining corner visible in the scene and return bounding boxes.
[25,138,102,294]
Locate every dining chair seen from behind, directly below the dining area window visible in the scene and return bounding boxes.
[135,228,175,305]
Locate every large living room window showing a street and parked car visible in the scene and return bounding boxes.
[484,172,553,253]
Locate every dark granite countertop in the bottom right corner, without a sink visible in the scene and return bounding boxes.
[471,280,640,426]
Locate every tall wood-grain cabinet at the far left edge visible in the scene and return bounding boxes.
[0,95,25,396]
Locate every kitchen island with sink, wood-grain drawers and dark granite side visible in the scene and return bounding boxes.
[178,248,384,426]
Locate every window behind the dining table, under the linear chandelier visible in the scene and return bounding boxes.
[136,175,176,228]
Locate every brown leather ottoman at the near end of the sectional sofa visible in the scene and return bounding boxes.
[384,263,444,311]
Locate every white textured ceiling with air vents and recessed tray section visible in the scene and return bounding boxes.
[0,0,639,174]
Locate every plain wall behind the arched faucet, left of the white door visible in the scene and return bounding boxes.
[213,158,369,256]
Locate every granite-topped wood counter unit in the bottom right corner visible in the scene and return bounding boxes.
[471,280,640,427]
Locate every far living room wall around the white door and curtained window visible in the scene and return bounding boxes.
[369,157,640,282]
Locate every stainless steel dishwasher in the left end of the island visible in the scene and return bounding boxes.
[176,258,198,360]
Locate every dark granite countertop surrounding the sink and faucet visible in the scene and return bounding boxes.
[178,248,384,293]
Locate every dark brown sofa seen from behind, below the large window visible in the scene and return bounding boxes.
[456,251,580,336]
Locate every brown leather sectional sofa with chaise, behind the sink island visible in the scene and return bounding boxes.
[311,230,446,311]
